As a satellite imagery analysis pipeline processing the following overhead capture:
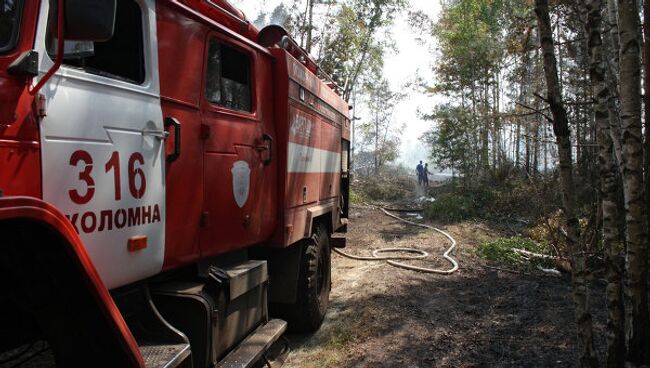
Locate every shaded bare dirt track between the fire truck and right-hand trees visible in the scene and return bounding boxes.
[285,207,605,368]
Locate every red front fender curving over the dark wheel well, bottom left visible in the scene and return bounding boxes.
[0,196,144,367]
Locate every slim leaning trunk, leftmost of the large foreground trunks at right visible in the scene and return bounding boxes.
[535,0,598,368]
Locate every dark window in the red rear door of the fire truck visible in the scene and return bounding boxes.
[205,39,251,111]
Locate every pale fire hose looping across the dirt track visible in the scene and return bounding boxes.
[333,206,458,275]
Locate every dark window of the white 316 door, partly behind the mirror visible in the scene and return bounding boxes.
[47,0,146,84]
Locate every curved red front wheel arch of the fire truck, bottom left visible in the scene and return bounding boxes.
[0,197,144,367]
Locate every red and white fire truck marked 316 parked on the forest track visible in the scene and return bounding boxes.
[0,0,350,367]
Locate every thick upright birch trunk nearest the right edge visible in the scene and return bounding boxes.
[618,0,650,365]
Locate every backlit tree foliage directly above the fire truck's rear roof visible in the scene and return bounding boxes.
[247,0,400,100]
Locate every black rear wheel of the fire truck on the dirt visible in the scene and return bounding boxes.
[285,224,332,332]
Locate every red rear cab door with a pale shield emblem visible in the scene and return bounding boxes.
[201,35,273,256]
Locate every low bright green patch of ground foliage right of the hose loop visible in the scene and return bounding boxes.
[476,236,554,269]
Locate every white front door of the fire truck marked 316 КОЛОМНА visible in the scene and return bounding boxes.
[37,0,168,288]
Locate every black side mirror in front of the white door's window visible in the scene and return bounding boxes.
[65,0,117,41]
